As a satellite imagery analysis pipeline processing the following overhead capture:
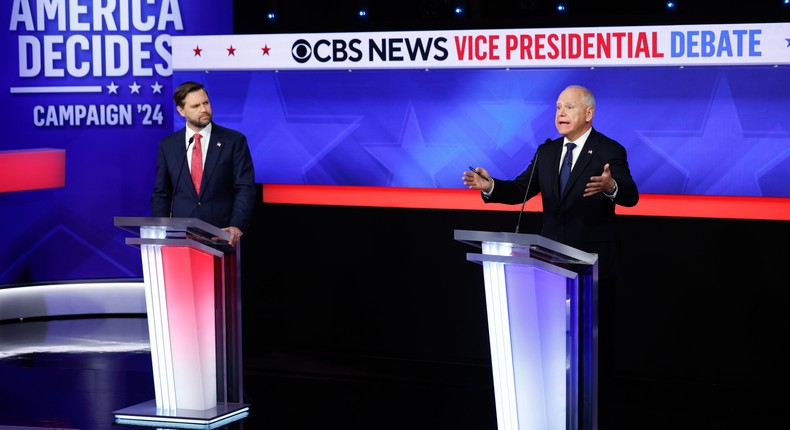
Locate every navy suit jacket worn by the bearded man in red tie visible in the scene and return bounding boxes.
[151,123,255,232]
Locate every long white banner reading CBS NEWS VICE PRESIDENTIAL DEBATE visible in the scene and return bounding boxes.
[173,23,790,71]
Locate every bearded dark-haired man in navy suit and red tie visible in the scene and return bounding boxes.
[151,82,255,245]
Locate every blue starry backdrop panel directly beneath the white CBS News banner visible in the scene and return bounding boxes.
[175,66,790,197]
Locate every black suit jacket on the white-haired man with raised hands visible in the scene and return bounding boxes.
[483,129,639,279]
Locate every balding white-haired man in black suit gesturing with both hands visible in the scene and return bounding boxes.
[463,85,639,429]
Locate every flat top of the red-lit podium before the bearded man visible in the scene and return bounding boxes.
[114,217,230,248]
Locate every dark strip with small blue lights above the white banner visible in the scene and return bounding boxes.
[233,0,790,34]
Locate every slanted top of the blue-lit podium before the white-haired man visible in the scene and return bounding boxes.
[453,230,598,266]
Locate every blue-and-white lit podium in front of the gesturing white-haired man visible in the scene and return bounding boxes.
[454,230,598,430]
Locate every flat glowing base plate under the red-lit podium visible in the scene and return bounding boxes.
[115,400,250,429]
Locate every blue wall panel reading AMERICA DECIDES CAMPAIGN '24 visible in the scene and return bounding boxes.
[0,0,233,284]
